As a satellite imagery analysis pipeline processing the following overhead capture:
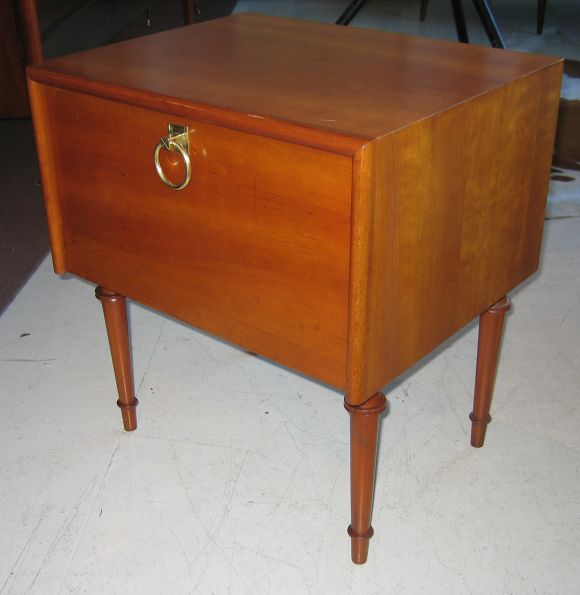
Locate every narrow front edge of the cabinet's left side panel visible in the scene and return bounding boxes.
[28,80,68,274]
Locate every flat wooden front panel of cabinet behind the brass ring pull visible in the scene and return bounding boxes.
[33,86,352,388]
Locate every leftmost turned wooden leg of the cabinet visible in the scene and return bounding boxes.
[95,286,138,432]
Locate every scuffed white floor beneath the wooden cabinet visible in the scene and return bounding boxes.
[0,213,580,595]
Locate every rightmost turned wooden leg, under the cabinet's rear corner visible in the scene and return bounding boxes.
[469,297,511,448]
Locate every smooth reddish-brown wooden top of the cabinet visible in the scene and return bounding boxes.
[29,14,558,140]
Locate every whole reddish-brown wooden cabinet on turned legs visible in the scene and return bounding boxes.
[29,14,562,563]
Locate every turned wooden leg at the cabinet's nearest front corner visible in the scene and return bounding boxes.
[344,393,387,564]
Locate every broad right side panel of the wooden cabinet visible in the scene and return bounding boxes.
[348,64,561,402]
